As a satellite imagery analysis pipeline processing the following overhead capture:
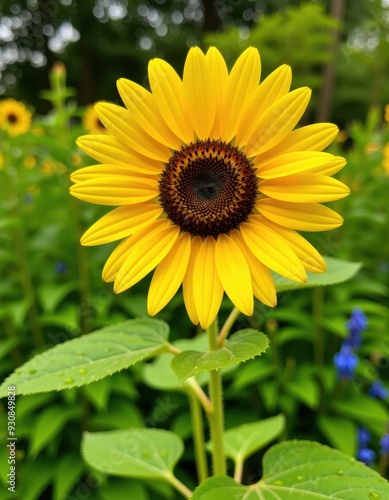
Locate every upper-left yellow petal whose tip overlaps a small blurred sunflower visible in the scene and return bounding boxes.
[95,102,171,162]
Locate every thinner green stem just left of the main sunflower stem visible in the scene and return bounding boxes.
[188,391,208,483]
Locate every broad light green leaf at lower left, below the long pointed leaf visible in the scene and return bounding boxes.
[81,429,184,480]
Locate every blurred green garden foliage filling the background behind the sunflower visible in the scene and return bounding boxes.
[0,0,389,500]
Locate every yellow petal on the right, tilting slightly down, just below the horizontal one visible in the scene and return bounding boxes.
[255,198,343,231]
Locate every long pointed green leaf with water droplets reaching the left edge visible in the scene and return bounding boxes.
[0,319,169,397]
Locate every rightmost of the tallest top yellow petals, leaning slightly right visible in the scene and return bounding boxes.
[220,47,261,142]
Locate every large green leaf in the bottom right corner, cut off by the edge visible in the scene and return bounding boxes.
[192,441,389,500]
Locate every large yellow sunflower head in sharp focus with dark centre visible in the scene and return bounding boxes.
[71,47,349,328]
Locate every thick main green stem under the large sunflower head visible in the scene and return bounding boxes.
[207,319,226,476]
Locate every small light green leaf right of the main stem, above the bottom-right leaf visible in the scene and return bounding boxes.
[220,415,285,462]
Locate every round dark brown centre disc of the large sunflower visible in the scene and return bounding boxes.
[159,140,258,238]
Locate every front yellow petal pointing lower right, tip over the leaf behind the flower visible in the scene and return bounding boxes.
[240,215,307,283]
